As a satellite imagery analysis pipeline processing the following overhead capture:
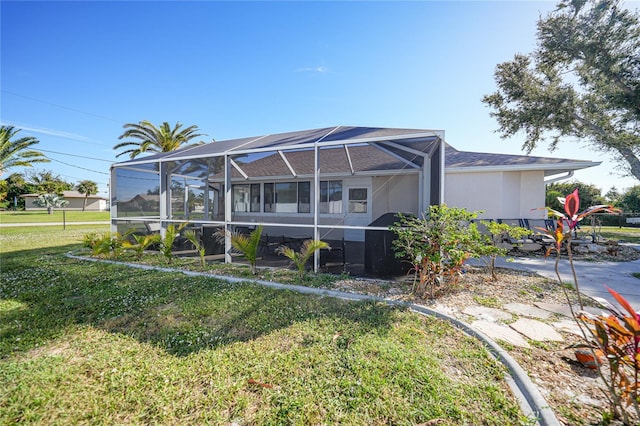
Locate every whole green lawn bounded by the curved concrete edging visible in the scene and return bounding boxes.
[0,227,526,425]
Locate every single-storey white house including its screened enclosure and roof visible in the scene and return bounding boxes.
[111,126,599,272]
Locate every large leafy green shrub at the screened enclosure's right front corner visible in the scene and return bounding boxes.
[389,204,481,298]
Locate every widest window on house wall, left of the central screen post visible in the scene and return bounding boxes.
[264,182,311,213]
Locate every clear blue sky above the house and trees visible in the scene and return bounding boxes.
[0,1,636,196]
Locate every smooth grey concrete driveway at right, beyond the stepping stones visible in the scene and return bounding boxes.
[475,244,640,311]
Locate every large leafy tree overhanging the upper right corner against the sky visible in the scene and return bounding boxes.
[483,0,640,179]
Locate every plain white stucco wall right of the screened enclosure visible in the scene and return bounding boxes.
[444,171,545,219]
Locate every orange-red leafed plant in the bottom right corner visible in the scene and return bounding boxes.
[576,288,640,425]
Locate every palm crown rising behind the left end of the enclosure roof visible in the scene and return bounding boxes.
[113,120,206,159]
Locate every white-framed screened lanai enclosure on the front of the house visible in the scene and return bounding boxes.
[111,126,444,273]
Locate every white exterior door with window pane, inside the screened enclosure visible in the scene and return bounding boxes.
[342,178,371,241]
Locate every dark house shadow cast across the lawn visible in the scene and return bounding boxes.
[0,245,396,357]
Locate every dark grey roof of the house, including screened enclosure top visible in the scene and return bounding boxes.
[116,126,600,177]
